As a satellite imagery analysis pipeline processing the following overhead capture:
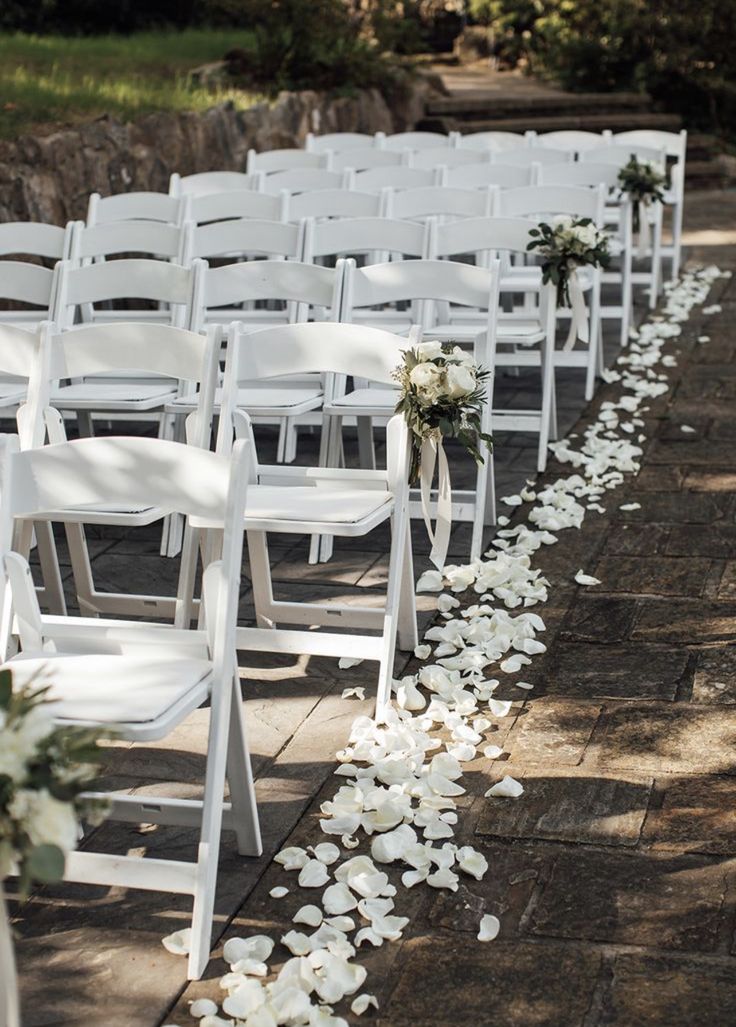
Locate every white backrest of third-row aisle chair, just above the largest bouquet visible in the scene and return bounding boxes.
[342,260,497,327]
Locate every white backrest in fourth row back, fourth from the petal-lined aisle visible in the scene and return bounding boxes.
[69,220,187,264]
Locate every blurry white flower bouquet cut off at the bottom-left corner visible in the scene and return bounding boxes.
[0,670,105,1027]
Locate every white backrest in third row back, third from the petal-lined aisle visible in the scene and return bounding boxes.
[52,258,204,329]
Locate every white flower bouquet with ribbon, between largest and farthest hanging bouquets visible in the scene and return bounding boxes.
[527,215,611,348]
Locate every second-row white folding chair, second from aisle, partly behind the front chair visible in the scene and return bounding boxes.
[44,322,222,607]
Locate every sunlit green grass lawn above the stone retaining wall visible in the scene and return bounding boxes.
[0,29,258,139]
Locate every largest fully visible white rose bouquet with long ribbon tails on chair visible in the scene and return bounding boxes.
[394,342,493,569]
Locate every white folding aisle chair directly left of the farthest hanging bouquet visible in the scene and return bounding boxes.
[539,161,633,346]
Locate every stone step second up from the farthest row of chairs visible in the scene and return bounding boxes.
[427,89,651,118]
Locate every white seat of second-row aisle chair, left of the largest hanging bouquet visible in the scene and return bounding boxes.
[245,484,393,534]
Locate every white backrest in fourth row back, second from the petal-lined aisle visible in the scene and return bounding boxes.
[304,218,428,263]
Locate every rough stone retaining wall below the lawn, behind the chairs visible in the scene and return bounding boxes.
[0,76,432,224]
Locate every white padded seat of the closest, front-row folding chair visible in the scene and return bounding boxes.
[5,653,211,734]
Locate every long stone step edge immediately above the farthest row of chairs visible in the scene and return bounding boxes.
[422,105,682,132]
